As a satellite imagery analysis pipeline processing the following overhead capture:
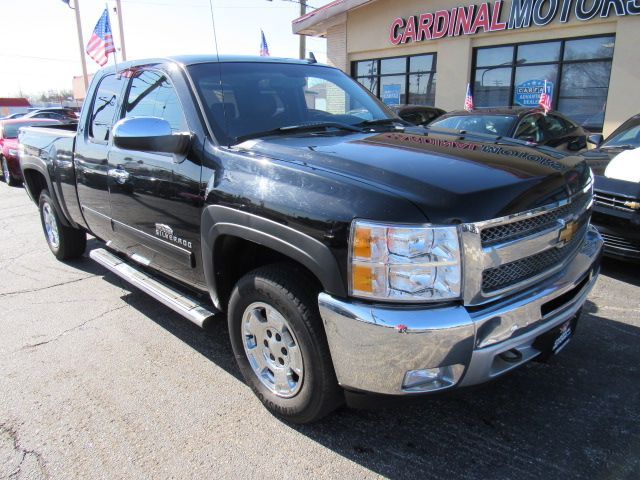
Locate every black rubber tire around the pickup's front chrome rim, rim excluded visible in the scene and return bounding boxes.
[228,264,344,423]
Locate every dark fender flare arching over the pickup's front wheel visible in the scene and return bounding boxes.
[201,205,346,308]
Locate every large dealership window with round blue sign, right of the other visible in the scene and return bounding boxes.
[472,35,615,132]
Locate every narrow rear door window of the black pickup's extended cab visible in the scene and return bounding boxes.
[89,75,126,144]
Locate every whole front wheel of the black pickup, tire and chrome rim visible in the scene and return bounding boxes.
[228,264,343,423]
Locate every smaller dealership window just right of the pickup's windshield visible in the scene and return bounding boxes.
[352,53,436,106]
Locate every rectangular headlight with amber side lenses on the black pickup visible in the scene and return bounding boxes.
[349,220,462,302]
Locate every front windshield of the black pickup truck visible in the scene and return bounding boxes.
[189,62,401,145]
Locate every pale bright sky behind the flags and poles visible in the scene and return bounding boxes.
[0,0,330,97]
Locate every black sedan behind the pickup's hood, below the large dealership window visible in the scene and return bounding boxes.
[429,107,589,152]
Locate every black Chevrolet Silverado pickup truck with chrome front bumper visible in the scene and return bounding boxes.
[20,56,602,422]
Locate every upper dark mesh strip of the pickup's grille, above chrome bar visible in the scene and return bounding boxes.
[480,195,589,247]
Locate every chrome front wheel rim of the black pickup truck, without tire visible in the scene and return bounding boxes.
[242,302,304,398]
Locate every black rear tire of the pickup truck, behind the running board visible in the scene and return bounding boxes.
[38,190,87,260]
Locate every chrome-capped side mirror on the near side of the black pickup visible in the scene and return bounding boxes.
[113,117,191,155]
